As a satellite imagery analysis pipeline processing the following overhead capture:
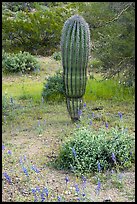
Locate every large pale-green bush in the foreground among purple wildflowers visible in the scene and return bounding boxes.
[54,127,134,173]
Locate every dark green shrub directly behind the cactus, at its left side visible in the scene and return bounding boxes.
[42,71,64,101]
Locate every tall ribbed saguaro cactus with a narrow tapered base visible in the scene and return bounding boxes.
[61,15,90,121]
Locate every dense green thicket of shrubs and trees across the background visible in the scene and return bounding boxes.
[2,2,135,86]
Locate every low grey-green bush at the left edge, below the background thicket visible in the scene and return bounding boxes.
[2,51,39,73]
